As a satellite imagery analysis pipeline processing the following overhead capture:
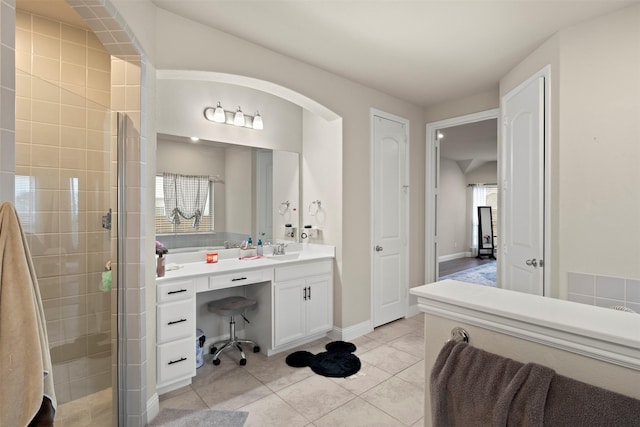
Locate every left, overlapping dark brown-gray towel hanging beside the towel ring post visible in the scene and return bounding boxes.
[430,341,554,427]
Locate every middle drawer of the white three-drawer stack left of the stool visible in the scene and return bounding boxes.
[157,298,196,344]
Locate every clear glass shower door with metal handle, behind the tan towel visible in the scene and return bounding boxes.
[15,70,118,427]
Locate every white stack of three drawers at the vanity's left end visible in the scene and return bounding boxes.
[156,279,196,393]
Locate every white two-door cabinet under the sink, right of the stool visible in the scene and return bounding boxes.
[273,260,333,349]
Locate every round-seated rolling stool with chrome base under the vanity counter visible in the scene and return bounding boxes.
[207,296,260,366]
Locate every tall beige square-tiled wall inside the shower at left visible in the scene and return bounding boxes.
[15,11,112,403]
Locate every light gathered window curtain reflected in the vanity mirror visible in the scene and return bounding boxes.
[162,173,209,228]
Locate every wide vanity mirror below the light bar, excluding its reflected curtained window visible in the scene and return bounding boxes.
[156,134,300,250]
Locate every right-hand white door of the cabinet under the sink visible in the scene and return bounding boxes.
[305,275,333,335]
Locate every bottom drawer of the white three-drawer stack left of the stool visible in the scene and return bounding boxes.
[158,338,196,385]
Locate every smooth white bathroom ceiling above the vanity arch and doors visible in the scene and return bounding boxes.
[152,0,640,107]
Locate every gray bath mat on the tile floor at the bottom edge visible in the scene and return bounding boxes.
[147,409,249,427]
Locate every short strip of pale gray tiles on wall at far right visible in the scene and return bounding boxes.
[568,273,640,313]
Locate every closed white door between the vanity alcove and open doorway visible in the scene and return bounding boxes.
[371,113,409,327]
